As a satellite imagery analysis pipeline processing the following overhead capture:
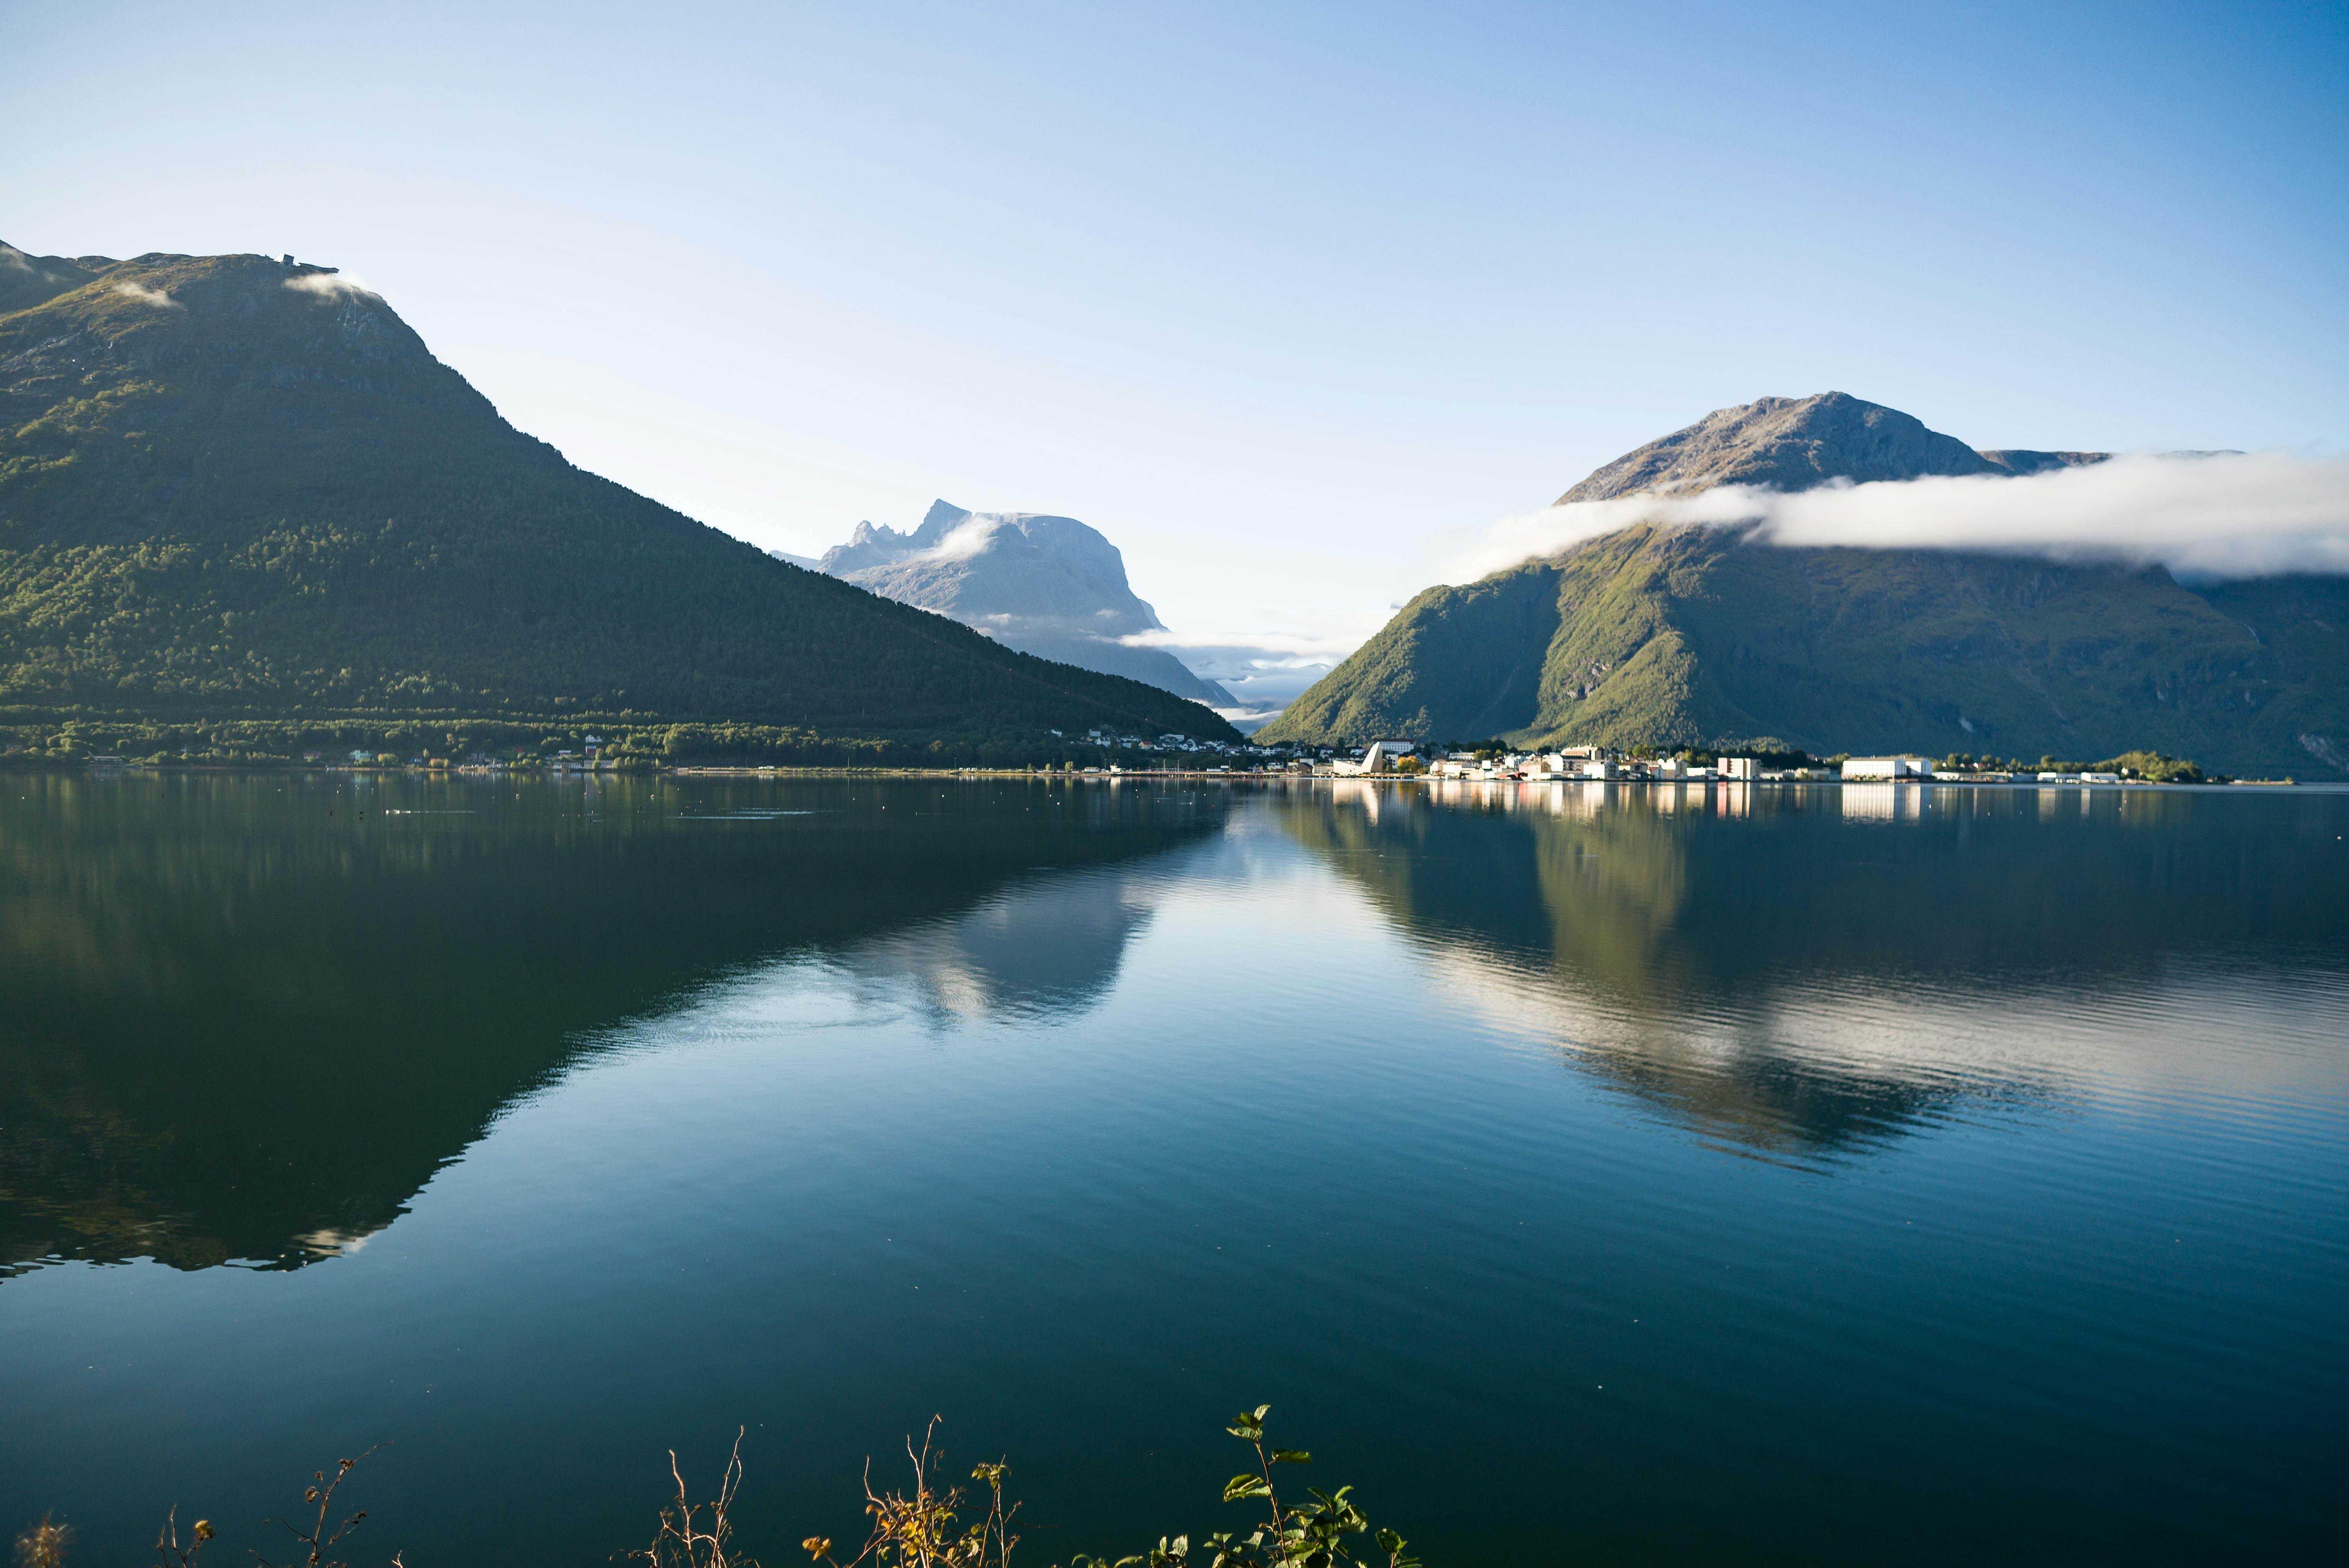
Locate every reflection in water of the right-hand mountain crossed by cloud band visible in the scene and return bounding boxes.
[1273,782,2349,1162]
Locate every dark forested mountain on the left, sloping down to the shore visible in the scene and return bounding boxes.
[0,249,1235,747]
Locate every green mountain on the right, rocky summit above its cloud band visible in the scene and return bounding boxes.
[1257,392,2349,777]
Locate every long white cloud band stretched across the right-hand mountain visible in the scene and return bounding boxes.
[1447,453,2349,582]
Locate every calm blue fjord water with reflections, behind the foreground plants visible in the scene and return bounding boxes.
[0,775,2349,1568]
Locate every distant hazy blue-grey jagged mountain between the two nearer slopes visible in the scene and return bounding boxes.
[822,500,1238,709]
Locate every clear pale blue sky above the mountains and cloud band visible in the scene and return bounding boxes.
[0,0,2349,699]
